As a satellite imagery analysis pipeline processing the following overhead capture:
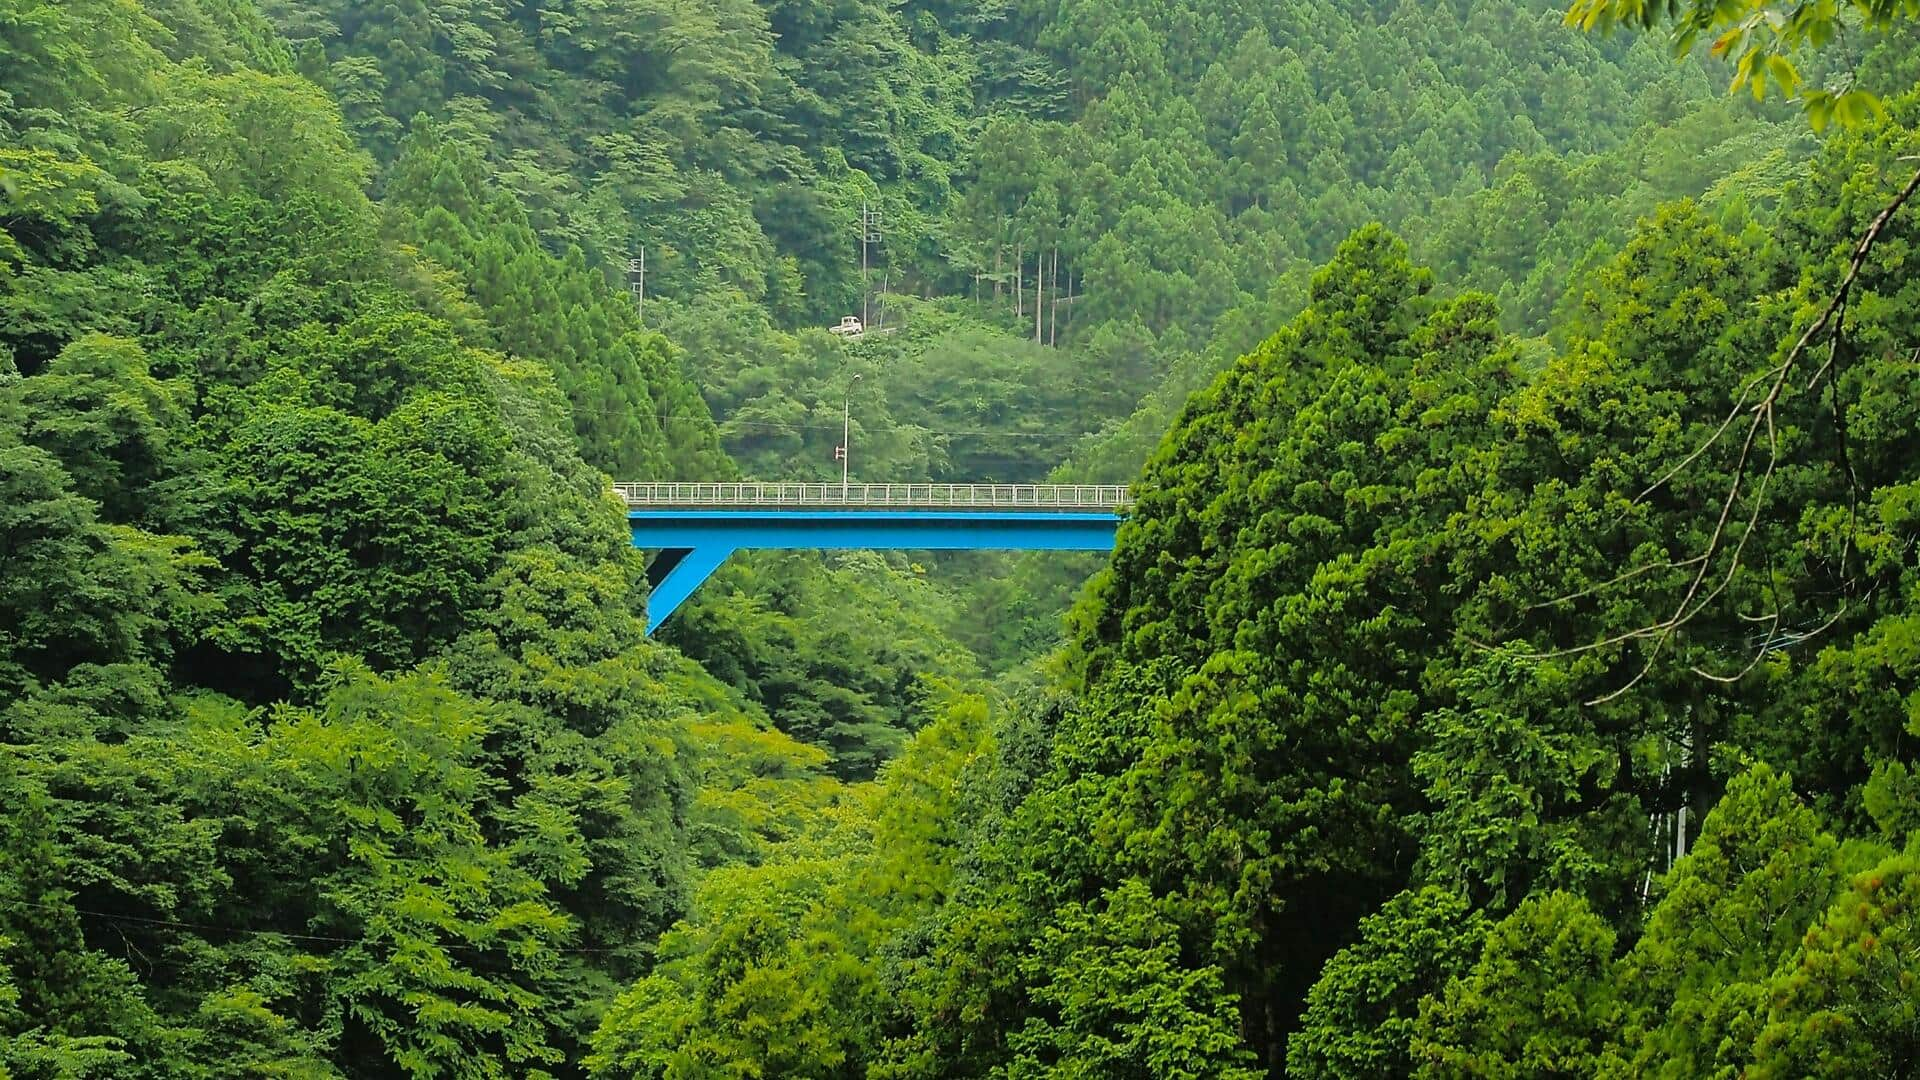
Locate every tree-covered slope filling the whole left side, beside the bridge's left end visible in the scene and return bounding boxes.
[0,0,856,1078]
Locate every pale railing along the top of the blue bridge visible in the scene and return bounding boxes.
[612,480,1133,509]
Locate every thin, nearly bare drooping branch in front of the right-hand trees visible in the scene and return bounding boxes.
[1534,158,1920,705]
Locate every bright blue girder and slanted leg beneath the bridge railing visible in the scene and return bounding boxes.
[626,507,1119,634]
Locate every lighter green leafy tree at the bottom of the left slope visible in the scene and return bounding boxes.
[280,669,572,1078]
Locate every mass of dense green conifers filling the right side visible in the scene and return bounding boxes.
[908,102,1914,1076]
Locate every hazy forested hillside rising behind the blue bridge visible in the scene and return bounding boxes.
[265,0,1803,480]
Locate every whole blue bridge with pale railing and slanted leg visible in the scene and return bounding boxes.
[614,482,1129,634]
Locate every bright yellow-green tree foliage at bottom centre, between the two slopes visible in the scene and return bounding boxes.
[588,696,989,1080]
